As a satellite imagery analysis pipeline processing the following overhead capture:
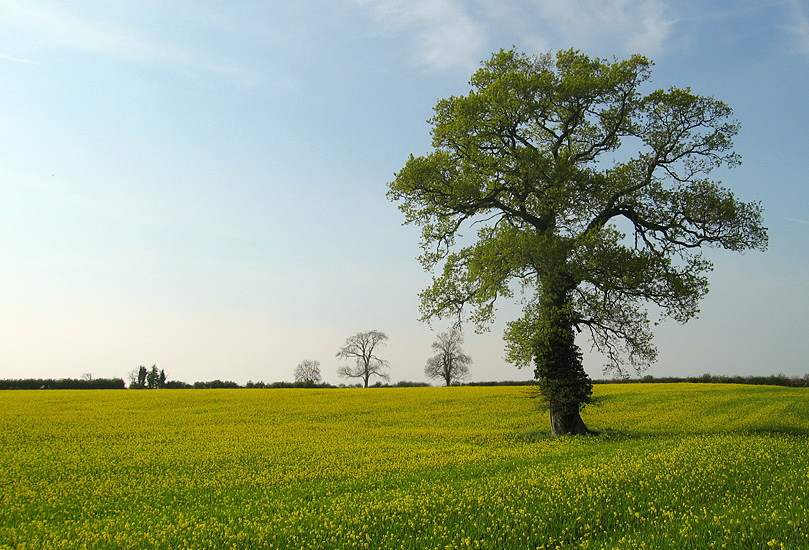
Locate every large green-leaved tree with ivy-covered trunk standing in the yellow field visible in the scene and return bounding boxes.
[388,50,767,434]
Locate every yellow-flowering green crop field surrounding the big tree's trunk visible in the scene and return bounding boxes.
[0,384,809,550]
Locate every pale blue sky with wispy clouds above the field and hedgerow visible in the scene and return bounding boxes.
[0,0,809,383]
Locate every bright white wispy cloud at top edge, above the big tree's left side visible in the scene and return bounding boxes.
[355,0,486,70]
